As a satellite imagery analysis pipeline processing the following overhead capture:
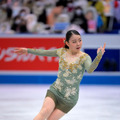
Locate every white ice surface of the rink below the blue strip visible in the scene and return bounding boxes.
[0,84,120,120]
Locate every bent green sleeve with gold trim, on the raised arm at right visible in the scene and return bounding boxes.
[85,51,102,73]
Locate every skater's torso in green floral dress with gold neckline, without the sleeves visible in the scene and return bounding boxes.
[51,48,86,104]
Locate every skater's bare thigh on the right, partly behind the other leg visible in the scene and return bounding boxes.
[47,109,65,120]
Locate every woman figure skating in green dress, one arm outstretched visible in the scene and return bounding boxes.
[15,30,105,120]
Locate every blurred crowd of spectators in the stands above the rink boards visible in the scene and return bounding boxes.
[0,0,120,34]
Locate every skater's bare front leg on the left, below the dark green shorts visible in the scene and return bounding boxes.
[34,97,55,120]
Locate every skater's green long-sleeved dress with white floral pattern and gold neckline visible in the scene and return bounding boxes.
[28,48,102,105]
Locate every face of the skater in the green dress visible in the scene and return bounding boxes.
[66,34,82,53]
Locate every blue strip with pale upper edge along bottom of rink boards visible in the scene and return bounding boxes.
[0,71,120,85]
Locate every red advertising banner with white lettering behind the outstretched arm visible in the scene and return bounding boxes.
[0,37,64,71]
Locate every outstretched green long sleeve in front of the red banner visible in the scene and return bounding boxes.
[27,48,58,57]
